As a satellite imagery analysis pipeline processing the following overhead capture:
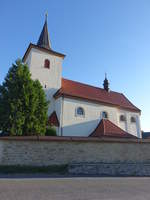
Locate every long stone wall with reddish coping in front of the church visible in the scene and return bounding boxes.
[0,137,150,166]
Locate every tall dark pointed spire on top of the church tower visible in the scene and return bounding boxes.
[37,13,51,49]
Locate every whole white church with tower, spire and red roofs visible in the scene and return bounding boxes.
[23,16,141,138]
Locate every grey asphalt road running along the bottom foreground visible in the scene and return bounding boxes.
[0,178,150,200]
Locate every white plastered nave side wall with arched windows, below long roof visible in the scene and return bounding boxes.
[61,98,141,137]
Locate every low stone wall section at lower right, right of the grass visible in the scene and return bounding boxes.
[68,163,150,176]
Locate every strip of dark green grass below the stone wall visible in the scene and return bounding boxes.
[0,165,68,174]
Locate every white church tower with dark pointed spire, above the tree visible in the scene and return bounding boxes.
[23,15,65,101]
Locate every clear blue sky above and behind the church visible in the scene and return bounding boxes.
[0,0,150,131]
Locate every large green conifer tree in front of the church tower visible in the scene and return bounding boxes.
[0,60,48,135]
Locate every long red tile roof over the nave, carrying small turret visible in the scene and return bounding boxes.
[54,78,140,112]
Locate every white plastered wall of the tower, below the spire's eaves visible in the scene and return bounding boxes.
[25,48,63,115]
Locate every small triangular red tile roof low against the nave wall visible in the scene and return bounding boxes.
[89,119,136,138]
